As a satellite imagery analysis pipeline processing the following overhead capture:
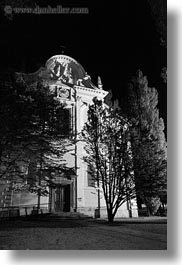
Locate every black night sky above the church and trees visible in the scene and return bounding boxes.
[0,0,167,126]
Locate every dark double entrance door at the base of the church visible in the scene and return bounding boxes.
[54,185,70,212]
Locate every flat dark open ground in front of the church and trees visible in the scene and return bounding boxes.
[0,218,167,250]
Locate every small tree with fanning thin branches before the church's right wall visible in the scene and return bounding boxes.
[82,98,135,222]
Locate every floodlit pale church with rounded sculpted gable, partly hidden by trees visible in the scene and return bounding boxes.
[0,54,138,217]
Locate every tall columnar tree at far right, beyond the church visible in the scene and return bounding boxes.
[125,70,167,213]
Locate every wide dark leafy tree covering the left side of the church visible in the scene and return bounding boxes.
[0,71,72,201]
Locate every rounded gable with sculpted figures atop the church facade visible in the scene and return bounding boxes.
[45,54,97,89]
